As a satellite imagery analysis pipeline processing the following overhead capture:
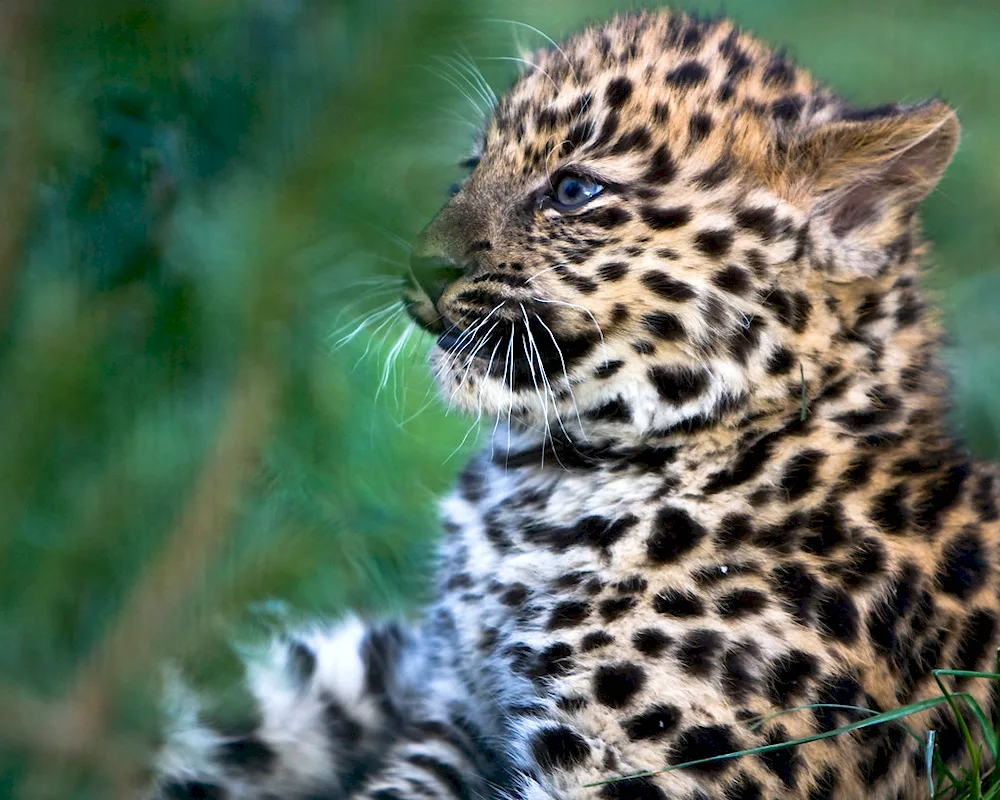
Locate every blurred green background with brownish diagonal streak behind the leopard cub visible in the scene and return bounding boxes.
[0,0,1000,798]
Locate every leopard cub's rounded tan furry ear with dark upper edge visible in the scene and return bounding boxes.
[788,100,959,280]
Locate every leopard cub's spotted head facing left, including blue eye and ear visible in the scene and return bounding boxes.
[407,13,957,435]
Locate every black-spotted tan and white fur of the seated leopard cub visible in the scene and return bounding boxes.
[152,7,1000,800]
